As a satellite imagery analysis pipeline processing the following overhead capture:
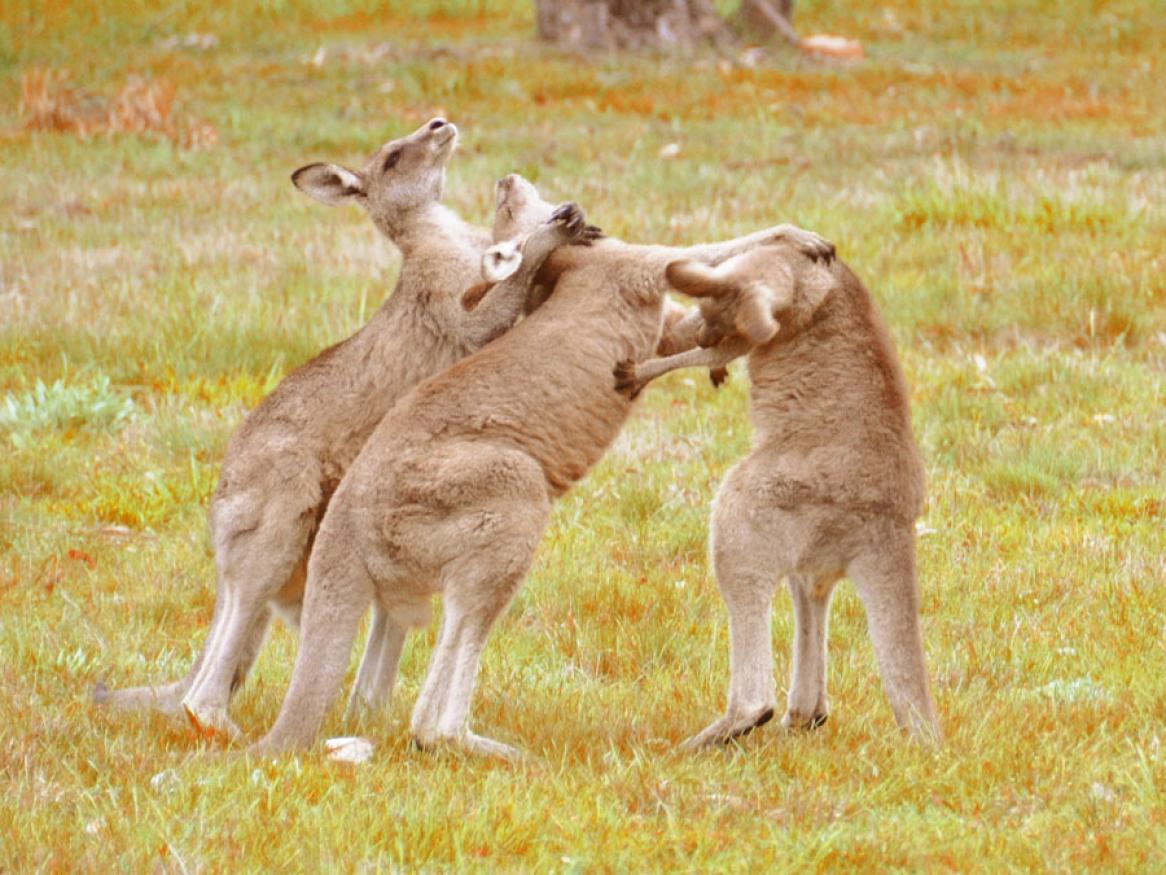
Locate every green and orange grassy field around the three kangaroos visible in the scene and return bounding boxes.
[0,0,1166,873]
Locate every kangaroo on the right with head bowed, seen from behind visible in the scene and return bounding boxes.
[616,245,940,748]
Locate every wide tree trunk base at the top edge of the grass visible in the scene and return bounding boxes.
[534,0,732,49]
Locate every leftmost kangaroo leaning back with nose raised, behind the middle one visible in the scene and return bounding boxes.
[94,119,573,737]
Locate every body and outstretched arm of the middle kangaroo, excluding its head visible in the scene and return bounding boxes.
[252,183,831,757]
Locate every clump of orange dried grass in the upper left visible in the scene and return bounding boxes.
[20,68,218,148]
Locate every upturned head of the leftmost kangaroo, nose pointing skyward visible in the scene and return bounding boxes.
[292,119,457,237]
